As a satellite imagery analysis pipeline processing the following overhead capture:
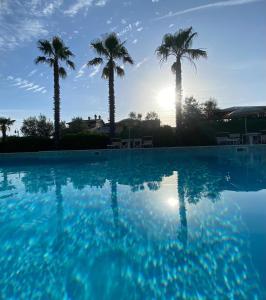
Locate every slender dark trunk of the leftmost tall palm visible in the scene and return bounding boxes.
[54,60,60,148]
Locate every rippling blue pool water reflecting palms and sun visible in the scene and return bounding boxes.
[0,147,266,300]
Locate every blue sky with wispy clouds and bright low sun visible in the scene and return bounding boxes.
[0,0,266,128]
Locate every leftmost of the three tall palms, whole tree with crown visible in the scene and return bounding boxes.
[35,36,75,147]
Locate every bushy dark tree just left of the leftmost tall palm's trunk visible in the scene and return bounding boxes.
[20,115,54,138]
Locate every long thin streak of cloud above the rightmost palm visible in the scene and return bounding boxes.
[155,0,265,20]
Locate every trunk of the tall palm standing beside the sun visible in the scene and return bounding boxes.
[176,58,182,132]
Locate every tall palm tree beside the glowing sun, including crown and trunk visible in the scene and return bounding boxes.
[156,27,207,131]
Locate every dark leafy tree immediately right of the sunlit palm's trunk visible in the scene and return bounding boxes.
[183,97,203,127]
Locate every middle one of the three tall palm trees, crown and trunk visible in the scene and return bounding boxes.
[88,33,134,137]
